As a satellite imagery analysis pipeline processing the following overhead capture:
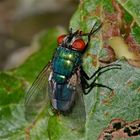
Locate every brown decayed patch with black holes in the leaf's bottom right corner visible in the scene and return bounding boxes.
[98,118,140,140]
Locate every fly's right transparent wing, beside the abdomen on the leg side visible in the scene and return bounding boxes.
[60,71,86,134]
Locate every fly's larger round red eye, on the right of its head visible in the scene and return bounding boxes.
[72,39,85,51]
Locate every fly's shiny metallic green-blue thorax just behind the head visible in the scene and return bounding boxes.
[52,47,82,83]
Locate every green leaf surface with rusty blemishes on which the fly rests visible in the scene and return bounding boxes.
[0,0,140,140]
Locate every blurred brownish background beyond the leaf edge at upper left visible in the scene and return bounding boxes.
[0,0,79,70]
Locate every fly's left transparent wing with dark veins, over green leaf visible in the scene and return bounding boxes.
[25,62,51,121]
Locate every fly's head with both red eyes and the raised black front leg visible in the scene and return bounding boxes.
[57,23,102,53]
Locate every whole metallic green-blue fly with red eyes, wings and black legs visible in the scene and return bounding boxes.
[25,23,120,121]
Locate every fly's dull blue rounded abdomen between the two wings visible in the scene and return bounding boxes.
[49,81,75,112]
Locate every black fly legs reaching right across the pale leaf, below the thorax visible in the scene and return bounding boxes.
[81,64,121,94]
